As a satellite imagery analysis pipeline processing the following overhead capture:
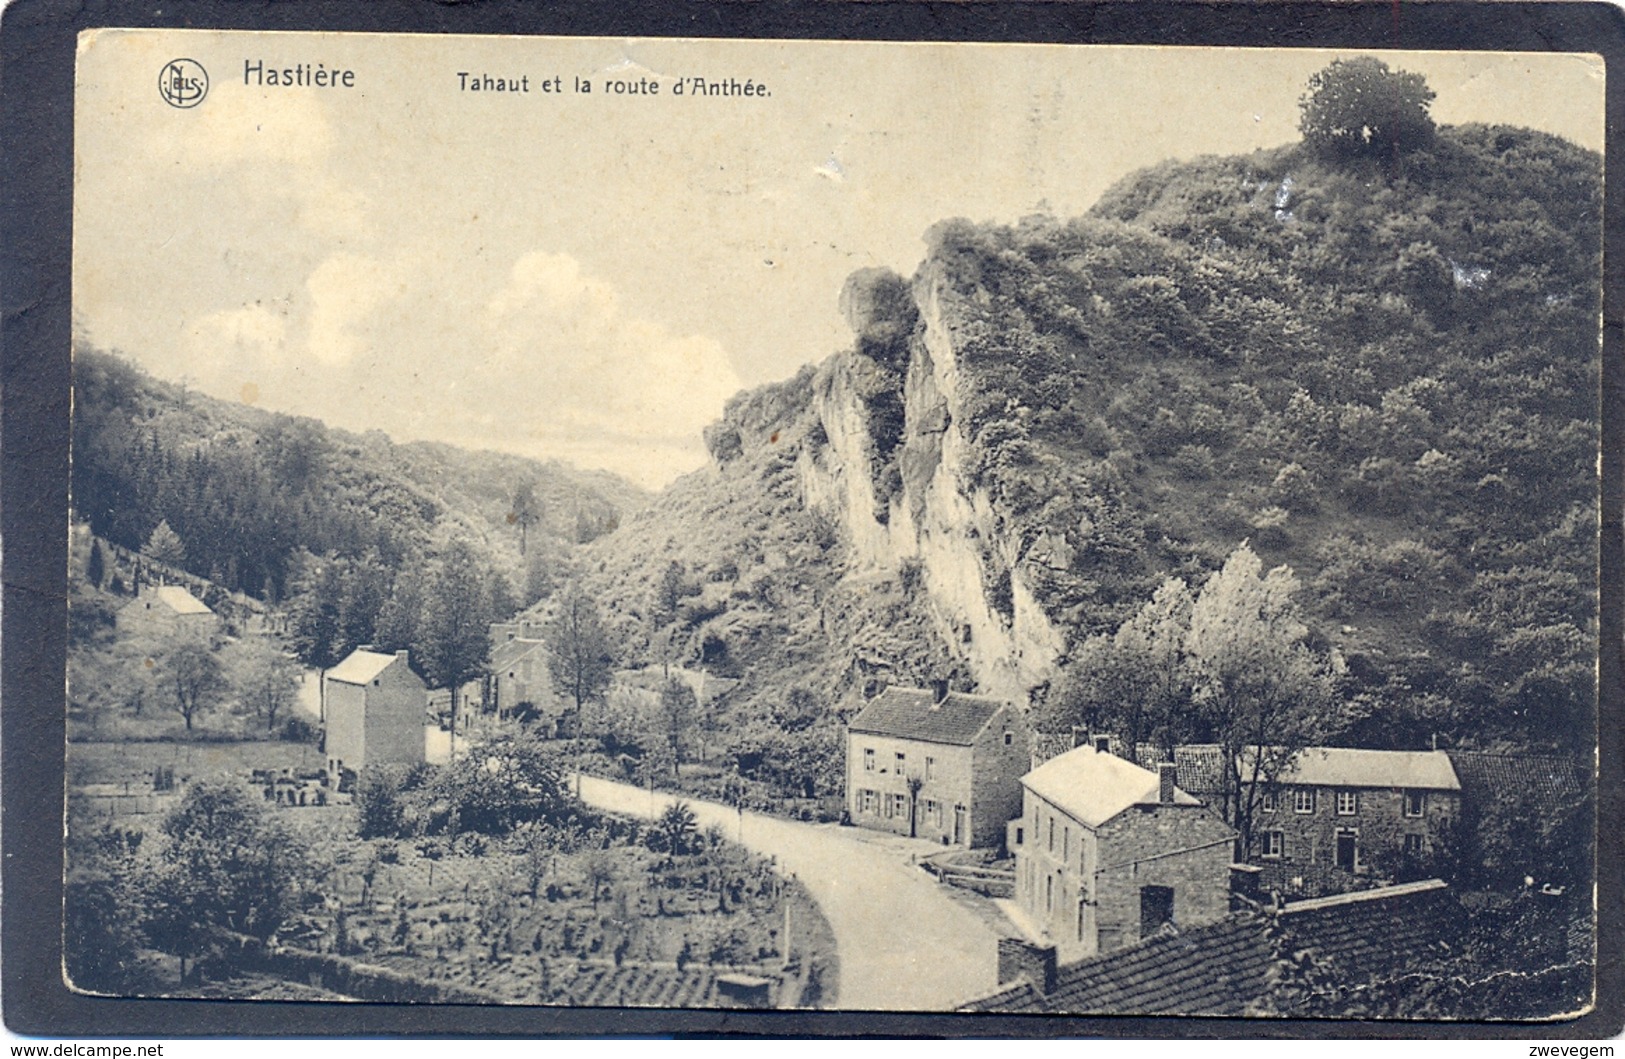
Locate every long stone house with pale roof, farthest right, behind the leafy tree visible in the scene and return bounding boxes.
[1243,747,1461,875]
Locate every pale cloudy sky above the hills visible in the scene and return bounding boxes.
[73,29,1602,487]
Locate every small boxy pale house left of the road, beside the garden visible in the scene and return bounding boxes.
[325,648,429,789]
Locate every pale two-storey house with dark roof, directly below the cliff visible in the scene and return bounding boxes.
[847,682,1032,846]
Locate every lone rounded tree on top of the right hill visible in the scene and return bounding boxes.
[1298,55,1433,158]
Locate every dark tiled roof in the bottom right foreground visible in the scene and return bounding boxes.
[960,879,1463,1015]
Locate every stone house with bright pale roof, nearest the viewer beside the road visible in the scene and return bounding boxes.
[1008,742,1235,960]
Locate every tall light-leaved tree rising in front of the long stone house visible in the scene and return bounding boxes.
[1185,542,1337,856]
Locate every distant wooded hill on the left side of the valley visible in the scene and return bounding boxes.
[72,348,647,601]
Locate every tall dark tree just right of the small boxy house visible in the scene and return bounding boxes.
[418,538,491,754]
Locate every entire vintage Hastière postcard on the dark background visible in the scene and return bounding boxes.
[63,29,1604,1027]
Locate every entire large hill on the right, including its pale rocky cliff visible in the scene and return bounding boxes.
[568,103,1601,747]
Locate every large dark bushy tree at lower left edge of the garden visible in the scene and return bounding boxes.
[148,780,307,978]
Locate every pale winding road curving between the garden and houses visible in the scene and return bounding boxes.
[580,776,998,1012]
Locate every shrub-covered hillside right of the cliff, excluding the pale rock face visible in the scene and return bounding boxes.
[890,125,1601,746]
